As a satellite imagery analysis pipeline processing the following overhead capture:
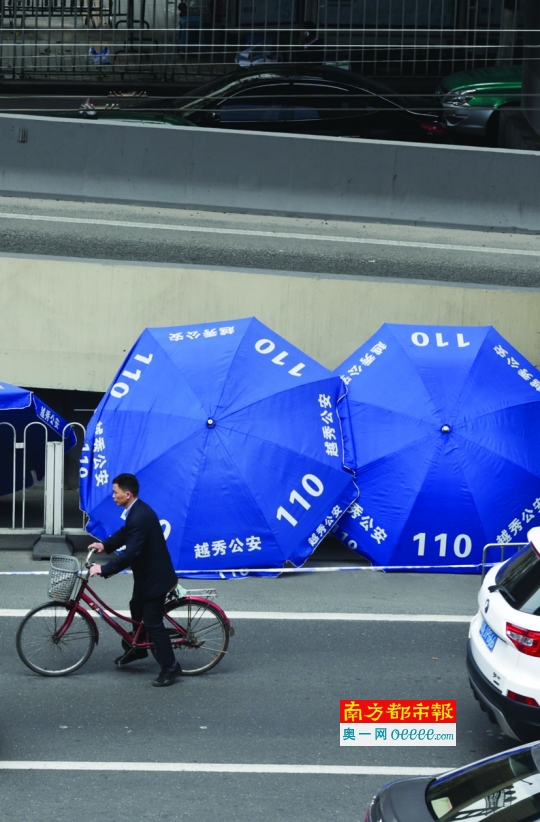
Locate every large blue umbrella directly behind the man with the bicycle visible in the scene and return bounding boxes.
[81,318,357,574]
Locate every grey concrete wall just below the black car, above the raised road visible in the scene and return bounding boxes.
[0,114,540,232]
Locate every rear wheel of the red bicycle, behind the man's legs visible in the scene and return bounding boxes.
[156,597,229,676]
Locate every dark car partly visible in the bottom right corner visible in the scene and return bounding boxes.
[366,742,540,822]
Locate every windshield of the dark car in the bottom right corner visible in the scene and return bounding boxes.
[426,746,540,822]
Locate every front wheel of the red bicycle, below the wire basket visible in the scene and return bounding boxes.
[16,602,96,676]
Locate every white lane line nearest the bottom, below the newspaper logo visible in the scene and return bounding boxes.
[0,760,452,776]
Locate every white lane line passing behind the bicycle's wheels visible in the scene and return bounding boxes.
[0,608,473,623]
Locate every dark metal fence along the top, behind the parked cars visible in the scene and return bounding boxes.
[0,0,523,84]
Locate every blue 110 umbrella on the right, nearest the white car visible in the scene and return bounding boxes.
[335,324,540,573]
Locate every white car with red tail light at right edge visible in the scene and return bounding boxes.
[467,527,540,742]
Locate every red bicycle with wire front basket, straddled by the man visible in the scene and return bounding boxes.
[17,551,234,676]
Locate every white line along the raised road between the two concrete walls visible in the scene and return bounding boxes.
[0,212,540,257]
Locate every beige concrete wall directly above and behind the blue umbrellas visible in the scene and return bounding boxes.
[0,255,540,391]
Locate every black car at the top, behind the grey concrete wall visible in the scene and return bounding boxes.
[77,64,444,142]
